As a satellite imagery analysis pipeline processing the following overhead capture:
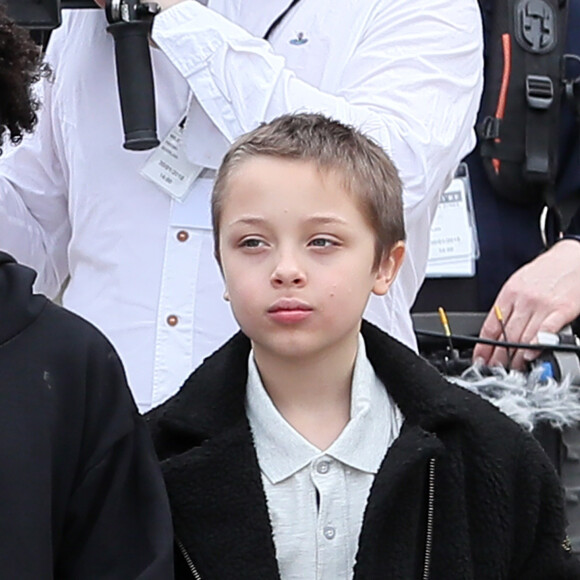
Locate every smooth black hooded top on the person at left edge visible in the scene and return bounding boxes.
[0,252,173,580]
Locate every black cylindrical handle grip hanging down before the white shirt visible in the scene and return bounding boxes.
[105,0,159,151]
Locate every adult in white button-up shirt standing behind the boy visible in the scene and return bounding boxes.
[0,0,483,411]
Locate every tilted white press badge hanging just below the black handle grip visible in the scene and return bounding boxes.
[140,117,203,201]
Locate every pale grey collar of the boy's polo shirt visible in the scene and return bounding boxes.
[246,335,402,484]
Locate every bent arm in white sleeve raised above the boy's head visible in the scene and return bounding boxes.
[153,0,483,219]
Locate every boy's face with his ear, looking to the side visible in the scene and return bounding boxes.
[219,156,404,357]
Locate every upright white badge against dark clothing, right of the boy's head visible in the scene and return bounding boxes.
[427,163,479,278]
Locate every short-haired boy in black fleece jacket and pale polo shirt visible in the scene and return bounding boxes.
[145,114,580,580]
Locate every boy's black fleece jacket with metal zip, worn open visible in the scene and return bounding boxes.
[146,323,580,580]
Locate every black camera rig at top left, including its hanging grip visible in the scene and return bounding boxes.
[0,0,159,151]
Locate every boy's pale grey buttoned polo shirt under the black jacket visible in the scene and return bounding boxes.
[246,336,403,580]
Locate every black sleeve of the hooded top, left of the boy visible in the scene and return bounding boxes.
[55,339,173,580]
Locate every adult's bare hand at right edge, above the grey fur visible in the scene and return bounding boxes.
[473,240,580,369]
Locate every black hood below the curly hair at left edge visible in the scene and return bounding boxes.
[0,252,48,345]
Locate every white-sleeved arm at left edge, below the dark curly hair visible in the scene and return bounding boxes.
[0,24,70,296]
